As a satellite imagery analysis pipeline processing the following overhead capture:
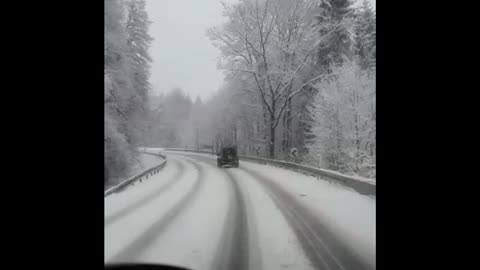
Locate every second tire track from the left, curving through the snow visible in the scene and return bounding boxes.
[110,160,205,262]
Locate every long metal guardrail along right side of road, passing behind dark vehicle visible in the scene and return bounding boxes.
[164,148,376,196]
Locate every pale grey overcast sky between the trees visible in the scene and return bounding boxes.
[146,0,375,100]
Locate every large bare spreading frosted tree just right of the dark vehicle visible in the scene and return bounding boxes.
[202,0,360,161]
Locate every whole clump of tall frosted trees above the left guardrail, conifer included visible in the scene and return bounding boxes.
[104,0,154,184]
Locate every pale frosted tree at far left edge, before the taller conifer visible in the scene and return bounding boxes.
[104,0,132,180]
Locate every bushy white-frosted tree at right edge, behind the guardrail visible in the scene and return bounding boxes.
[311,61,376,176]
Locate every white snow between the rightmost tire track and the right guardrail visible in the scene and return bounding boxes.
[240,161,376,268]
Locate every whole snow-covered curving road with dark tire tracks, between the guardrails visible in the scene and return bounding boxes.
[105,152,376,270]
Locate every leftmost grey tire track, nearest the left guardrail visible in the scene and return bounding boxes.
[105,160,185,227]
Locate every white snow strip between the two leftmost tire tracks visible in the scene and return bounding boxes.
[104,160,198,262]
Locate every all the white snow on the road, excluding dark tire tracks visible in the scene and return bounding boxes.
[109,152,376,269]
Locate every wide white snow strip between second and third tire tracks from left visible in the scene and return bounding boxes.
[139,157,229,270]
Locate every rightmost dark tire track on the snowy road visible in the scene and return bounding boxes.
[243,168,369,270]
